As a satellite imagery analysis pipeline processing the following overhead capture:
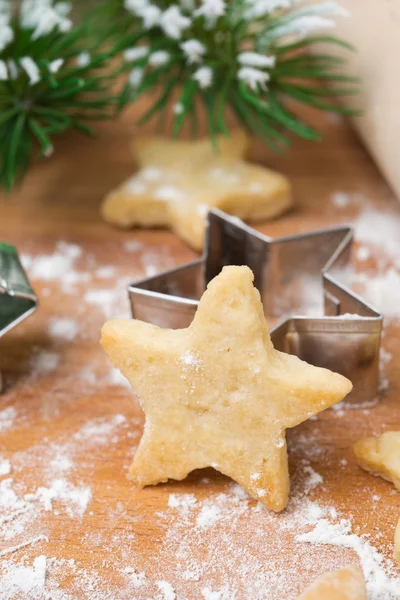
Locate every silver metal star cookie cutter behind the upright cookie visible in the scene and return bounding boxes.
[128,209,383,404]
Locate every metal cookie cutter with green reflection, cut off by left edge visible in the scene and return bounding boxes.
[0,242,38,393]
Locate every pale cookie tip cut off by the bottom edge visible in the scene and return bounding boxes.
[299,567,367,600]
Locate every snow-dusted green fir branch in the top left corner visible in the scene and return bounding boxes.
[0,0,124,190]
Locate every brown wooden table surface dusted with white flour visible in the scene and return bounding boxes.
[0,108,400,600]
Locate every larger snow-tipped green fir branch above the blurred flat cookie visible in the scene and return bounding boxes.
[113,0,359,149]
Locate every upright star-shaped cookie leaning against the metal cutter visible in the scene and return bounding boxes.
[101,267,352,511]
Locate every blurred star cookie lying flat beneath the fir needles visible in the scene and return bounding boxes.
[102,130,292,250]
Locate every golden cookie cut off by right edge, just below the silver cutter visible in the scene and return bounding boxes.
[353,431,400,490]
